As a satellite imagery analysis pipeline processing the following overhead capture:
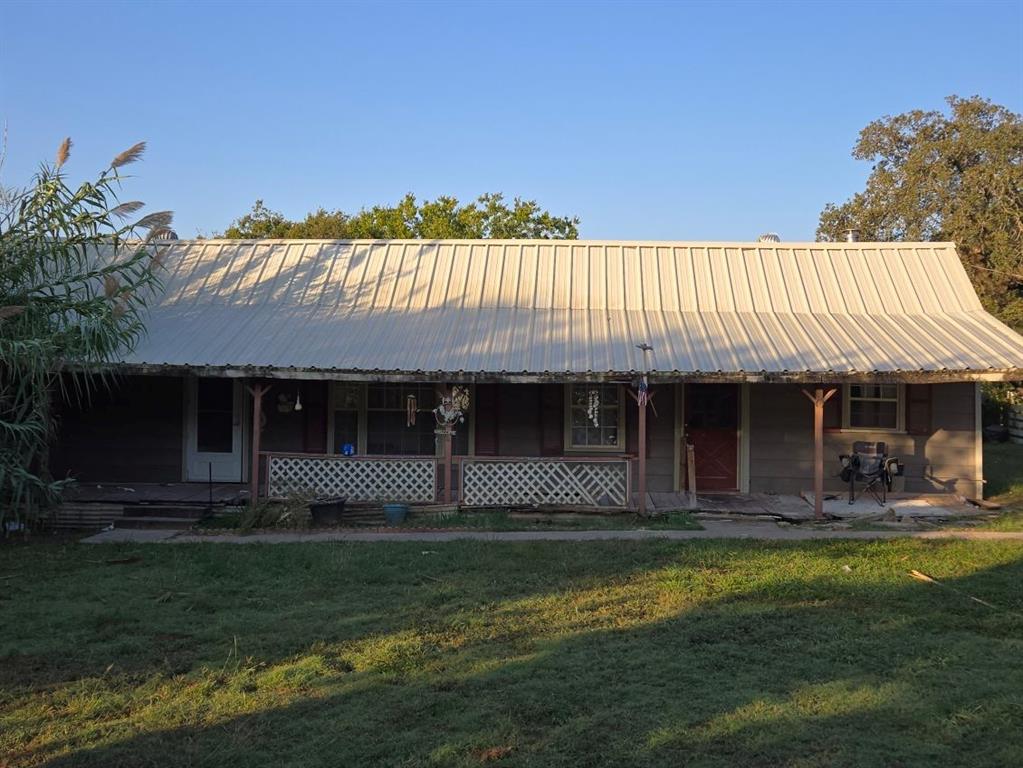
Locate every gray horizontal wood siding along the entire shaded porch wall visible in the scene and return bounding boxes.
[50,376,978,496]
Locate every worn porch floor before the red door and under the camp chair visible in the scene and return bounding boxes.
[647,491,989,523]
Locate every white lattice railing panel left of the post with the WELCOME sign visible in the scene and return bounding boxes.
[266,453,437,503]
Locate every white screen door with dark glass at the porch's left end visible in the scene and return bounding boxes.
[185,378,241,483]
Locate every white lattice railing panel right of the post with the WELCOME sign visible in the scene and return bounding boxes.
[461,457,629,507]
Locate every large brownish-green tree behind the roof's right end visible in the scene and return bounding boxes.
[817,96,1023,329]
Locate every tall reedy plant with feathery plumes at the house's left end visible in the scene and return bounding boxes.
[0,139,171,531]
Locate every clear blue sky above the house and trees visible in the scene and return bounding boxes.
[0,0,1023,240]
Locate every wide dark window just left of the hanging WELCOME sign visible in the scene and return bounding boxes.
[366,383,437,456]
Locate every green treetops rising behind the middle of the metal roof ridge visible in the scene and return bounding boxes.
[222,193,579,240]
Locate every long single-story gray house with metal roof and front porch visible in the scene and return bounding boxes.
[50,240,1023,506]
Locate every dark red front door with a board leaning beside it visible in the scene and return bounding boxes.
[682,385,739,492]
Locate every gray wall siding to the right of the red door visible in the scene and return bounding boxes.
[749,383,979,496]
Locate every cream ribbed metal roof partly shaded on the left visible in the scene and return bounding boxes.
[116,240,1023,378]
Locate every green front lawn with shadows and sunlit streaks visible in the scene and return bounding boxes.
[0,540,1023,768]
